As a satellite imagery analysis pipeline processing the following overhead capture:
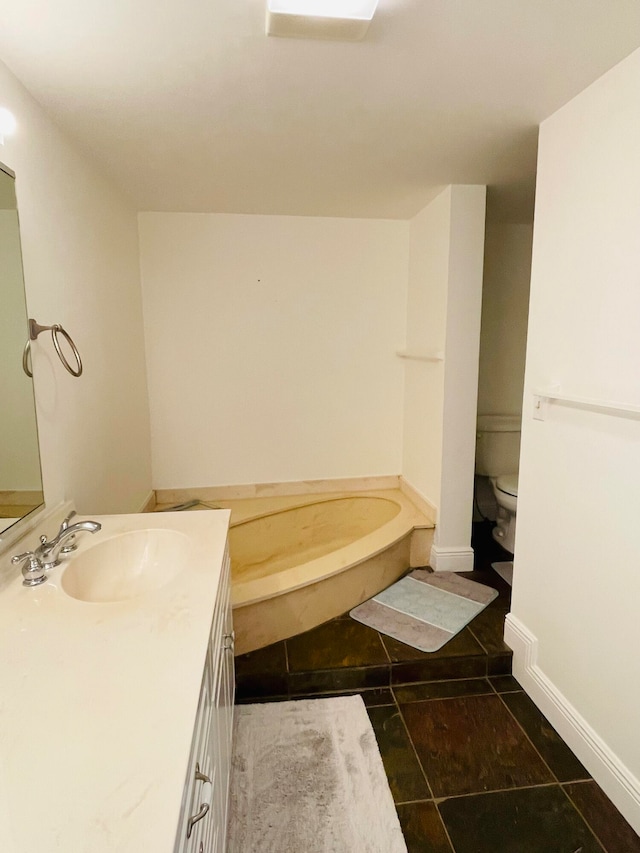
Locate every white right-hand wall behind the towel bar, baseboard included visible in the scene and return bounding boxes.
[507,45,640,830]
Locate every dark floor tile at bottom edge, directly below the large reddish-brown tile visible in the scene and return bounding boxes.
[438,785,602,853]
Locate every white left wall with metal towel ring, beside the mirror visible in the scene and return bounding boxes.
[0,65,151,513]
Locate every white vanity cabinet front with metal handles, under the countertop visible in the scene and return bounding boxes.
[174,548,235,853]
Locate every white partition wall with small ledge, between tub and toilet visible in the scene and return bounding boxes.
[402,186,486,570]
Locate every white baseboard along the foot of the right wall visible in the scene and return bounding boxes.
[504,613,640,833]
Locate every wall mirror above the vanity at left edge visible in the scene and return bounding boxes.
[0,163,44,533]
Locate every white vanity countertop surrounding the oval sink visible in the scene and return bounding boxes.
[0,510,229,853]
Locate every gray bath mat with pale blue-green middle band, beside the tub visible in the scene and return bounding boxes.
[350,569,498,652]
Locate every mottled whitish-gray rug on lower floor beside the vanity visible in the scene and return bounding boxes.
[229,696,407,853]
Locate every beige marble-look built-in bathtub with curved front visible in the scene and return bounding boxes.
[226,489,434,654]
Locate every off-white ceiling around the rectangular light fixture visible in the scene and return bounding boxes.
[0,0,640,222]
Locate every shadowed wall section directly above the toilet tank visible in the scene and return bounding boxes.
[478,224,533,415]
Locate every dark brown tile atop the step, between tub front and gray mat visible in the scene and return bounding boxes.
[285,619,389,672]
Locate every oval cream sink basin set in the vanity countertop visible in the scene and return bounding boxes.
[61,529,192,602]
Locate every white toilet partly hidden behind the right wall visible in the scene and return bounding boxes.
[476,415,520,554]
